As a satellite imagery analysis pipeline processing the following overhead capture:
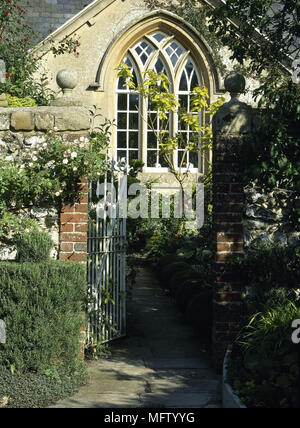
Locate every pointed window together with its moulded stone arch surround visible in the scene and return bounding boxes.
[96,13,220,172]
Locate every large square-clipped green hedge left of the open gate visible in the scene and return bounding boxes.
[0,261,86,372]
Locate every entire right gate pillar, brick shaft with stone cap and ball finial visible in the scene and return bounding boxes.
[212,72,253,367]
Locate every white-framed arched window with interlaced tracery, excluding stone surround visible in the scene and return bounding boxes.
[116,31,201,171]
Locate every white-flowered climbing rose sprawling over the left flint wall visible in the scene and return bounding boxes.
[0,132,109,242]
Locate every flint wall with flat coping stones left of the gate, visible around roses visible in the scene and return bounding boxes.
[0,107,91,260]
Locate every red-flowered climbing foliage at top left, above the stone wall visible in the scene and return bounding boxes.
[0,0,79,105]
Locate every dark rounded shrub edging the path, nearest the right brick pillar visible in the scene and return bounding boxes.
[185,288,213,344]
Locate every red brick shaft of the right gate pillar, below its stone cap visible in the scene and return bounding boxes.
[213,136,244,365]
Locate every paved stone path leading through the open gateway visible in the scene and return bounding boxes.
[53,268,221,409]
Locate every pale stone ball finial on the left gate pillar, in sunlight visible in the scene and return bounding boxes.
[52,68,82,107]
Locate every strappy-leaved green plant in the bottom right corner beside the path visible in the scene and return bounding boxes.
[229,302,300,408]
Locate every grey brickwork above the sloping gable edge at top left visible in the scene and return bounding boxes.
[19,0,93,39]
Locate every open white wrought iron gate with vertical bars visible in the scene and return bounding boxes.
[88,161,127,343]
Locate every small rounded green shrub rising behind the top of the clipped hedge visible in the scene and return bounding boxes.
[16,230,53,263]
